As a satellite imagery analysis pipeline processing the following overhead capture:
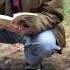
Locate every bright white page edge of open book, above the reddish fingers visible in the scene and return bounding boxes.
[0,12,38,25]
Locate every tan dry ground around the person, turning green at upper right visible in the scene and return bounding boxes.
[0,0,70,70]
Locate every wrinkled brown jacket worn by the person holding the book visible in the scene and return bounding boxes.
[0,0,66,46]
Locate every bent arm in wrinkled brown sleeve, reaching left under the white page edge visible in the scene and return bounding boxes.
[14,0,63,32]
